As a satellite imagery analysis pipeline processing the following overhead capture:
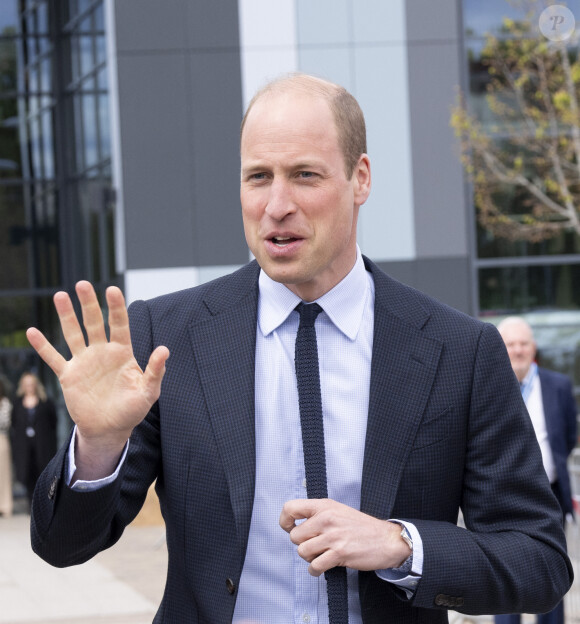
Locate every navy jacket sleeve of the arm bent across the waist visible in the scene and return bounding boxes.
[410,325,573,614]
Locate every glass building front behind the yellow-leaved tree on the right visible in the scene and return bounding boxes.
[463,0,580,397]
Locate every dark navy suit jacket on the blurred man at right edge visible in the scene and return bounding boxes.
[538,367,577,514]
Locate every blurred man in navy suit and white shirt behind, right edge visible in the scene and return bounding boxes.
[496,316,577,624]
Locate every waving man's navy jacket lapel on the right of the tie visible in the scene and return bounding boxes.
[361,260,442,518]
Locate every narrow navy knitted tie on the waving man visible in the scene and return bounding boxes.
[294,302,348,624]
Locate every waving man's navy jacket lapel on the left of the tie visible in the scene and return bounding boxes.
[190,271,258,552]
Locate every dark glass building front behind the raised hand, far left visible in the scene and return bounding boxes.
[0,0,119,404]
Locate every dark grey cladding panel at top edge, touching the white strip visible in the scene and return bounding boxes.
[186,0,240,49]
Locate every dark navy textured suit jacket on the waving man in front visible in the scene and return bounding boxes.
[32,259,572,624]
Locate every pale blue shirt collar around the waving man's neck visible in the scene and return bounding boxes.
[258,246,368,340]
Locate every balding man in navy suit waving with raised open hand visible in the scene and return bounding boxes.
[27,75,572,624]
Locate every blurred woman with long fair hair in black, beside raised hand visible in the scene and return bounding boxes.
[12,373,57,504]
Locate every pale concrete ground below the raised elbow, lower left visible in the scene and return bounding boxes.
[0,490,167,624]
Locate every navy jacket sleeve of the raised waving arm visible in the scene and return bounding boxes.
[31,302,160,567]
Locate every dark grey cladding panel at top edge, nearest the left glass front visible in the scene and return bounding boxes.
[113,0,190,54]
